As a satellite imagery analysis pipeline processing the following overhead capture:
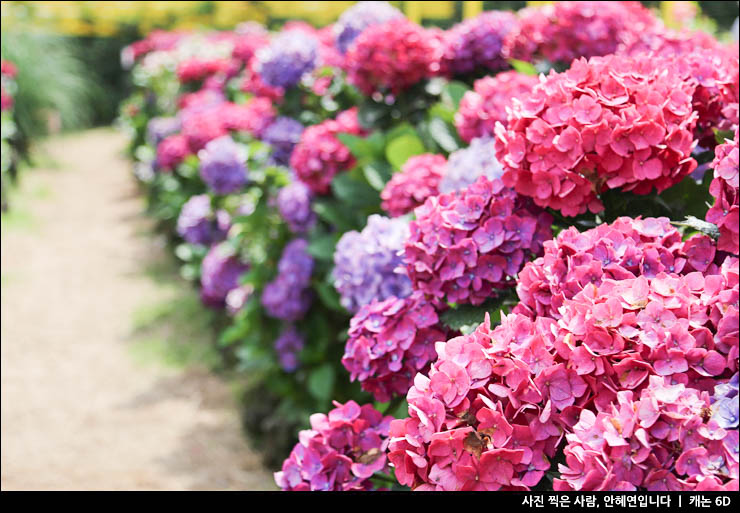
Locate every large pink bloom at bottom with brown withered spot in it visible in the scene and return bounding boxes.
[388,314,568,491]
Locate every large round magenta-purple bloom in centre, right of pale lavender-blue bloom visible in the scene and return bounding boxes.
[404,177,552,305]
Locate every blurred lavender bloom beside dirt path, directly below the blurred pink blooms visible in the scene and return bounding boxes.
[198,135,247,194]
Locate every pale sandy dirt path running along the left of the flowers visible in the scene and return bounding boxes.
[0,129,275,490]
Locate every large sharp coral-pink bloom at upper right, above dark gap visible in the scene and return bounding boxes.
[495,55,697,216]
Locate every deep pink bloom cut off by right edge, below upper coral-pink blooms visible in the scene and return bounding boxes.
[707,128,740,255]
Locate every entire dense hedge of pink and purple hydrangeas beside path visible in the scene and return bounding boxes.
[118,2,739,490]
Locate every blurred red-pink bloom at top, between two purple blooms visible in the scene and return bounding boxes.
[345,18,443,96]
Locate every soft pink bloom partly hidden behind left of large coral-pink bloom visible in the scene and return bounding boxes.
[455,71,539,143]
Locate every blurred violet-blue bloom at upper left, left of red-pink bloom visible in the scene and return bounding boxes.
[257,30,319,88]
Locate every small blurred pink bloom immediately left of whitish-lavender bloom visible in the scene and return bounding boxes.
[380,153,447,217]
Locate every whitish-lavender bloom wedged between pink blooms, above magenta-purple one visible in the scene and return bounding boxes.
[439,137,504,193]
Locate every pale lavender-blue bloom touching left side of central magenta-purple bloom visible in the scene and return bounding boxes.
[332,214,411,313]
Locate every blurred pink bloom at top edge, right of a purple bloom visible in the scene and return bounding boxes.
[504,2,658,64]
